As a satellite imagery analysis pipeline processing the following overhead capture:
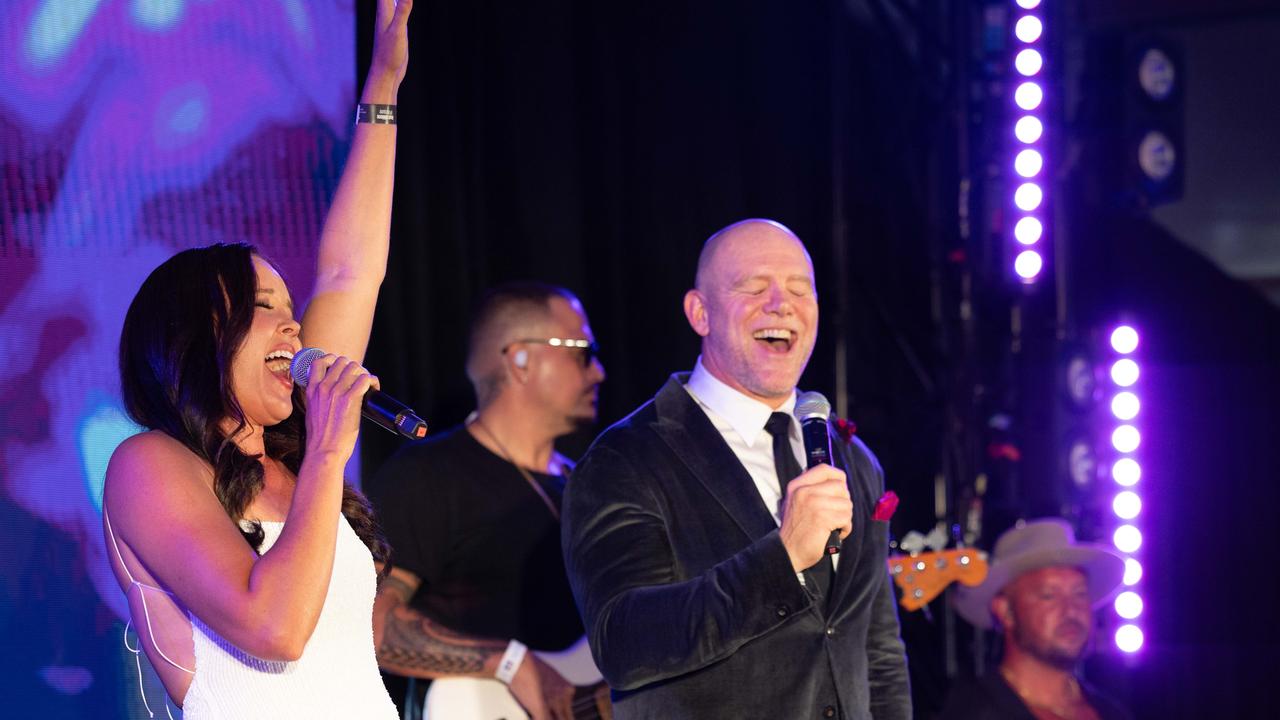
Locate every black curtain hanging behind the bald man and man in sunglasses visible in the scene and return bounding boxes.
[358,1,942,507]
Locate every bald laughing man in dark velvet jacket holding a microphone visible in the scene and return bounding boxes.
[563,219,911,720]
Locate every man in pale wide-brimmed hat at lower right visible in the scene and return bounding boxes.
[941,518,1130,720]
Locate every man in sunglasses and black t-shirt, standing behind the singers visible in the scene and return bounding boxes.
[370,283,604,720]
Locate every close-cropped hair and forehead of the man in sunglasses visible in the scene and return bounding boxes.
[467,282,581,407]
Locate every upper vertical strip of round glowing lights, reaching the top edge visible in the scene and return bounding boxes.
[1011,0,1047,284]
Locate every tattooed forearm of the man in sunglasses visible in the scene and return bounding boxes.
[378,575,506,678]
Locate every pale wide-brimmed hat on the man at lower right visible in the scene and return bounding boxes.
[951,518,1124,630]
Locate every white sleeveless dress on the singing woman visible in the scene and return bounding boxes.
[182,515,398,720]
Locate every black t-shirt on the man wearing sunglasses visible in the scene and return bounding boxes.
[369,428,582,650]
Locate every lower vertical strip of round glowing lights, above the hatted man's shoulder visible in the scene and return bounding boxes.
[1111,325,1143,653]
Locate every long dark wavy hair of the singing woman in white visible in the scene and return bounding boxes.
[120,243,389,562]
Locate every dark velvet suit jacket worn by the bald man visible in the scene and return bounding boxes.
[562,374,911,720]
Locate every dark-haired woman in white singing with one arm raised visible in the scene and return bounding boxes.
[102,0,411,720]
